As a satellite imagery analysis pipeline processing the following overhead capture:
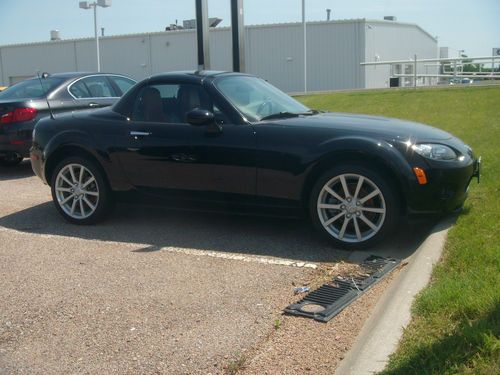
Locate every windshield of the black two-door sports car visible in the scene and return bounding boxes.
[215,76,311,121]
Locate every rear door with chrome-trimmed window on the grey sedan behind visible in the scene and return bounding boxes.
[68,75,120,109]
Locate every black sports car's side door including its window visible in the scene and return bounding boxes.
[114,83,256,199]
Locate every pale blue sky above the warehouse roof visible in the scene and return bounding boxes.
[0,0,500,56]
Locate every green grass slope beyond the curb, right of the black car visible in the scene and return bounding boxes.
[298,87,500,375]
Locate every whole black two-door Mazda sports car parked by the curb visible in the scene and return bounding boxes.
[31,72,479,248]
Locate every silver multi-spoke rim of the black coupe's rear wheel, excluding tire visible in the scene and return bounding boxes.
[54,164,99,220]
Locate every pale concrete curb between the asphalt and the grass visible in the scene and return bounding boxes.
[335,218,454,375]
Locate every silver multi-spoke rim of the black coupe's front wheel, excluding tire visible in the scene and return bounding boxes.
[317,173,387,243]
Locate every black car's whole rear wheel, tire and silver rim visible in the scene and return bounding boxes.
[50,156,113,225]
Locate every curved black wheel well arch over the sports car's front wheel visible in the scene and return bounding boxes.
[302,152,407,213]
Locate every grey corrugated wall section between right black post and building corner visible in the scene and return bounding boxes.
[247,21,364,92]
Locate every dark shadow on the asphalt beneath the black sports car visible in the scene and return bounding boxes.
[0,202,442,262]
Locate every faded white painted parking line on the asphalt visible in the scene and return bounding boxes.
[0,225,318,269]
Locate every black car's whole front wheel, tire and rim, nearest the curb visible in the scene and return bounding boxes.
[309,164,399,250]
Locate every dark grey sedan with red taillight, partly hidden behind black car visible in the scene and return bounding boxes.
[0,72,136,166]
